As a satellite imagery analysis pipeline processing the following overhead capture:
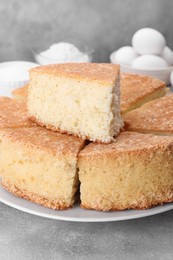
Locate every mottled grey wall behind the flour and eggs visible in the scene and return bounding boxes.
[0,0,173,62]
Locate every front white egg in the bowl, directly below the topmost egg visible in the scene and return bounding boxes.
[132,55,168,69]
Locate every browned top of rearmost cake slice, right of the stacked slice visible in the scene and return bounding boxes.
[121,73,166,111]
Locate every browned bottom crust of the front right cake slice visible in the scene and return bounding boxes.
[80,191,173,211]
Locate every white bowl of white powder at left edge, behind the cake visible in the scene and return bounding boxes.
[0,61,38,97]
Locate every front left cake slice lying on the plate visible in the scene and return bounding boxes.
[0,126,84,209]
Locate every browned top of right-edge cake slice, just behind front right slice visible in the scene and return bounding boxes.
[124,94,173,134]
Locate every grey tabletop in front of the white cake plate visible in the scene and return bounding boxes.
[0,203,173,260]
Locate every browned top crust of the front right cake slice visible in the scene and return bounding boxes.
[79,131,173,158]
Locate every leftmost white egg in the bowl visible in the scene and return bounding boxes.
[110,46,138,66]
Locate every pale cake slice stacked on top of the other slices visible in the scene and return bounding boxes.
[27,63,123,143]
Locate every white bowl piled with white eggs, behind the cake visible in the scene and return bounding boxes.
[110,27,173,84]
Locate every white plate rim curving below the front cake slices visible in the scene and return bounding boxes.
[0,187,173,223]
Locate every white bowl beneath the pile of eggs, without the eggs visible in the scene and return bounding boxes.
[110,53,173,85]
